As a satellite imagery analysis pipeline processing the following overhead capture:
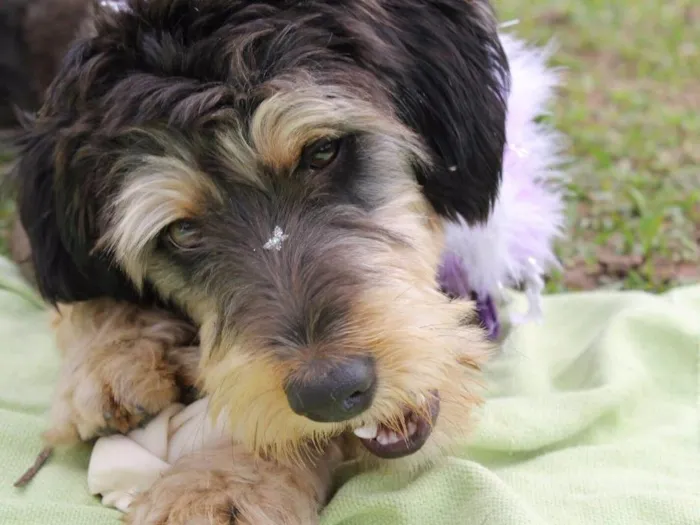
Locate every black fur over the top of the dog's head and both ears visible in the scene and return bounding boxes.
[9,0,508,302]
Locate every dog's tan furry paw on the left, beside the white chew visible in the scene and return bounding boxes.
[44,338,179,445]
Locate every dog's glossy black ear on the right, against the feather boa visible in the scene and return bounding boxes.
[360,0,509,223]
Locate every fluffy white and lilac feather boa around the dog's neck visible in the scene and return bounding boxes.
[438,35,564,339]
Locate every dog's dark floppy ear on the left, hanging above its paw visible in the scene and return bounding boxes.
[10,30,144,304]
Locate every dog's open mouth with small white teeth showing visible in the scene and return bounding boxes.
[353,391,440,459]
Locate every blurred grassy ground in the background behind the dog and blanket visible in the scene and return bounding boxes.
[0,0,700,292]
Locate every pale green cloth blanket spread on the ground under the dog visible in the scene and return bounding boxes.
[0,253,700,525]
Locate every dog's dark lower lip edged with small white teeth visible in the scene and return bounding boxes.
[360,392,440,459]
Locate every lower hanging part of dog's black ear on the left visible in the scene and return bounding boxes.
[12,114,134,304]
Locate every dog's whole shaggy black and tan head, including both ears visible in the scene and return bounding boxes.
[18,0,507,466]
